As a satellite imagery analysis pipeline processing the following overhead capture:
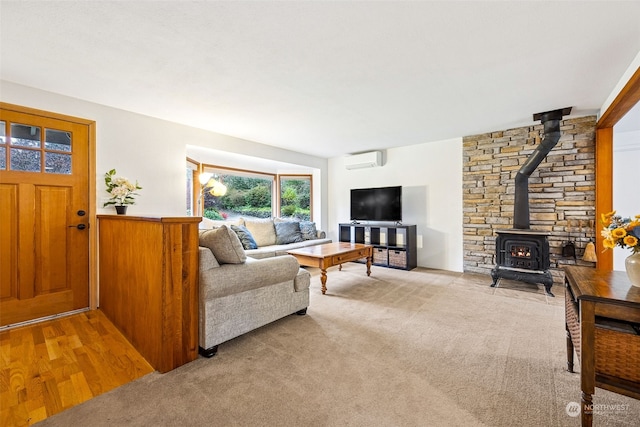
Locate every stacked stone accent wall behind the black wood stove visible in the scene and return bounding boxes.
[463,116,599,282]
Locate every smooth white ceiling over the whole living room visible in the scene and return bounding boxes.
[0,0,640,157]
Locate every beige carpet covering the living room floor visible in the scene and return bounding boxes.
[39,264,640,427]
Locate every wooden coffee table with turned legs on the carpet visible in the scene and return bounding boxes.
[288,242,373,295]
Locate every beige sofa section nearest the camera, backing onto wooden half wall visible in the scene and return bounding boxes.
[199,225,310,357]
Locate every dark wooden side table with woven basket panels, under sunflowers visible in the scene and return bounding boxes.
[564,266,640,426]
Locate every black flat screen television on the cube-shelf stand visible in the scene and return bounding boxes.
[350,186,402,222]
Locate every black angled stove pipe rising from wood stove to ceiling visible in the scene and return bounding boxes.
[513,108,571,230]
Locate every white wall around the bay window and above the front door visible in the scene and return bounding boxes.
[0,81,328,228]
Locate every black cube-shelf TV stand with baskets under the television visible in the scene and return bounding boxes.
[338,221,418,270]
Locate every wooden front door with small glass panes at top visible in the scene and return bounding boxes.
[0,106,90,326]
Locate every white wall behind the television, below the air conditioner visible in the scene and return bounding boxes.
[327,138,463,271]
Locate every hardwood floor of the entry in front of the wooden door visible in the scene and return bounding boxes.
[0,310,153,426]
